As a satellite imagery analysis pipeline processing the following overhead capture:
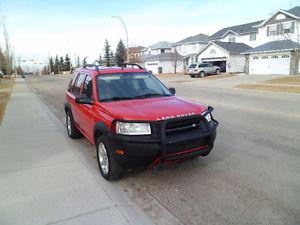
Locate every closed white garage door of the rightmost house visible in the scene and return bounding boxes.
[249,54,290,75]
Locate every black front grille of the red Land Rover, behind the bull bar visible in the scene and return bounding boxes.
[166,118,202,135]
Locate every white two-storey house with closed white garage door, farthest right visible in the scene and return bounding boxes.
[245,6,300,74]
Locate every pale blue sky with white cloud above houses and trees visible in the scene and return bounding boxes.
[0,0,300,67]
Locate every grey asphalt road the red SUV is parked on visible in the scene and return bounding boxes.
[28,76,300,225]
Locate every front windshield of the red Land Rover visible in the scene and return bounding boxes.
[97,73,171,102]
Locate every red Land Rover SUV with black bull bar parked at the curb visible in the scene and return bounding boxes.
[65,63,218,180]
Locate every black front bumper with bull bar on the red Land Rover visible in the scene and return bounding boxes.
[109,107,218,168]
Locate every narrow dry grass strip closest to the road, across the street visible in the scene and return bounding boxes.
[236,84,300,94]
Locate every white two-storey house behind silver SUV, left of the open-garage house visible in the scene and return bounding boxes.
[172,33,209,66]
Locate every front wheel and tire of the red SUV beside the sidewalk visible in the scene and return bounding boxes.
[96,136,124,181]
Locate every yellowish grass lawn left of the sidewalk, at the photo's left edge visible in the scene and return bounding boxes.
[0,79,15,125]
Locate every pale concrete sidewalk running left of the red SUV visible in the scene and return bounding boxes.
[0,79,151,225]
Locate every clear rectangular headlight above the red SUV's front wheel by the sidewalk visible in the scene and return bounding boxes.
[116,121,151,135]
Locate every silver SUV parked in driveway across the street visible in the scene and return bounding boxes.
[188,63,220,77]
